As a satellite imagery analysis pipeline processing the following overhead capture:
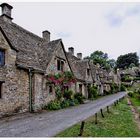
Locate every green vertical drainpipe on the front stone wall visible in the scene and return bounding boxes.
[29,69,33,113]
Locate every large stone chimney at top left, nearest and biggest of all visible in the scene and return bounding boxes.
[0,3,13,22]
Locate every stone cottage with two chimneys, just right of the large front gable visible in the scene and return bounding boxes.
[67,47,93,98]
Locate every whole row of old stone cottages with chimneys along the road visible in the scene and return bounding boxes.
[0,3,119,115]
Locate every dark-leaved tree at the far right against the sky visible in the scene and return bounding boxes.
[117,52,139,69]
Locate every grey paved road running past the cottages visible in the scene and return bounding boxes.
[0,92,126,137]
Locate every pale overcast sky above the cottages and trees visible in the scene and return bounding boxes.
[1,2,140,59]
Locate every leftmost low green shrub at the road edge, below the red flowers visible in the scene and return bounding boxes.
[47,100,61,110]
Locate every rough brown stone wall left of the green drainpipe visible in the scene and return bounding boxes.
[0,32,29,116]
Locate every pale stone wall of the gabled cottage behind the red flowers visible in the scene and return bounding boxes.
[34,44,75,109]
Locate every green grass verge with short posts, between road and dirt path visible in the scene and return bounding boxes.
[56,100,140,137]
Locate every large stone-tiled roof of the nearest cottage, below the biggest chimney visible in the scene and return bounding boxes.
[0,17,61,71]
